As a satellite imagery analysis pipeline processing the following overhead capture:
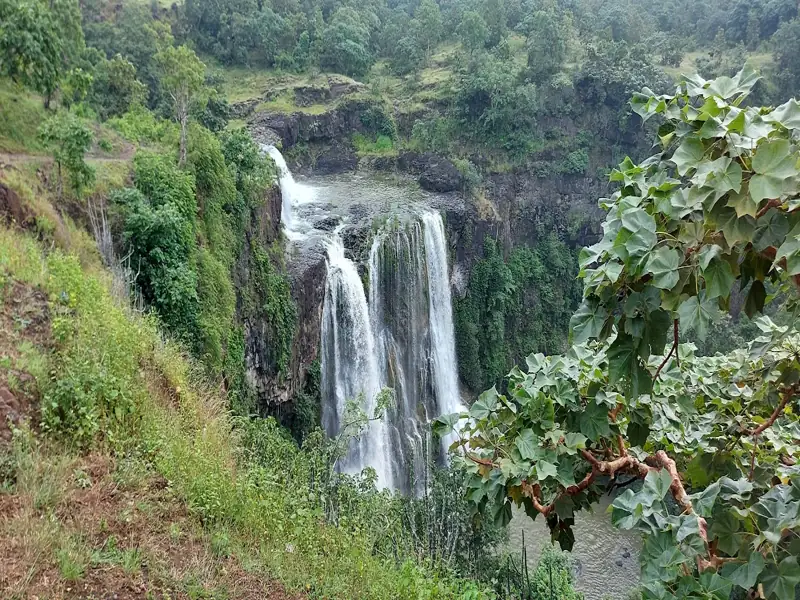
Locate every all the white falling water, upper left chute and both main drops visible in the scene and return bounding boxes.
[262,146,461,493]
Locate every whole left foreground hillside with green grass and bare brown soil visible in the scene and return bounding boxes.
[0,81,504,599]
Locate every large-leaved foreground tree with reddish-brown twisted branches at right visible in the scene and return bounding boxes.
[434,69,800,600]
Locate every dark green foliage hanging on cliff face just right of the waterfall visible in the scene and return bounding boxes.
[454,234,579,390]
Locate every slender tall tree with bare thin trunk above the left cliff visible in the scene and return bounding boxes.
[156,46,205,166]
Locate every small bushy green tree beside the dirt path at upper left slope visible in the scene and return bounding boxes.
[39,112,94,199]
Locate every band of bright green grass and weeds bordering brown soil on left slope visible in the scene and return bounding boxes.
[0,229,500,599]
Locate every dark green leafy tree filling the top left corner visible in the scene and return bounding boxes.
[0,0,64,108]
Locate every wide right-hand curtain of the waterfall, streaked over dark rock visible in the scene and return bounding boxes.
[370,212,461,491]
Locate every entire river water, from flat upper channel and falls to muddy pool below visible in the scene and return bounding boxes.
[265,147,640,600]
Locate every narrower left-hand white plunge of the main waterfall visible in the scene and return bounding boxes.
[322,235,392,487]
